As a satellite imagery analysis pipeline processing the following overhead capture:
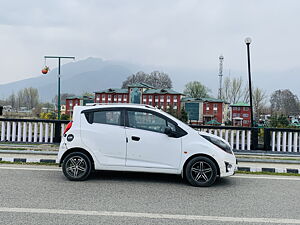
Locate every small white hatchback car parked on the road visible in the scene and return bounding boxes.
[57,104,236,186]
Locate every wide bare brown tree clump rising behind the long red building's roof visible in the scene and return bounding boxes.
[122,71,172,88]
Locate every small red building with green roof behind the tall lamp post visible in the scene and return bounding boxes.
[230,102,251,127]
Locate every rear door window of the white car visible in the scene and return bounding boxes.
[93,111,121,125]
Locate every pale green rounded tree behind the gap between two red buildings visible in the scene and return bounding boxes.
[183,81,211,98]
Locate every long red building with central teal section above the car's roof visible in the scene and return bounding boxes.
[94,83,182,111]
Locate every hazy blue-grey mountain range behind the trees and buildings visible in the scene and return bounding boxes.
[0,57,300,102]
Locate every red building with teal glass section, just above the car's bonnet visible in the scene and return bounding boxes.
[181,97,229,125]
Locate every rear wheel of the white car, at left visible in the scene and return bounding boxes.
[62,152,92,181]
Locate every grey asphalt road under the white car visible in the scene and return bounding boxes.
[0,164,300,225]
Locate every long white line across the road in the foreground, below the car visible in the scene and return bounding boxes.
[0,208,300,224]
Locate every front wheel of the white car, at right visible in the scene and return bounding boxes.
[185,156,217,187]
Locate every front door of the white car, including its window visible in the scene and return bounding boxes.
[125,109,181,169]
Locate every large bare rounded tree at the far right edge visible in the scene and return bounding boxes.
[270,89,300,116]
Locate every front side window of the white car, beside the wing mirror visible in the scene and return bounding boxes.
[128,111,172,133]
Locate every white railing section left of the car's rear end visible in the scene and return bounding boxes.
[0,119,67,143]
